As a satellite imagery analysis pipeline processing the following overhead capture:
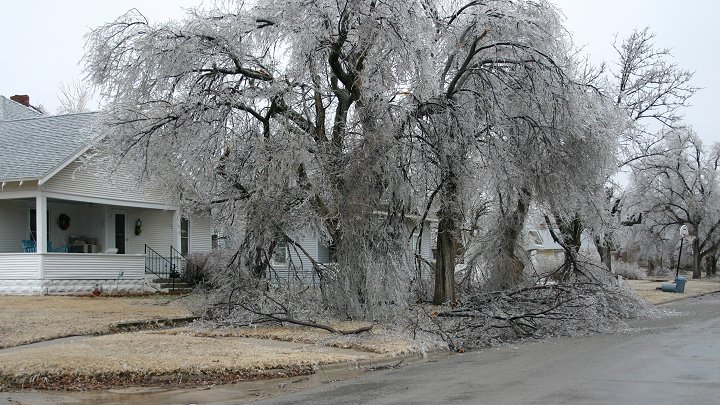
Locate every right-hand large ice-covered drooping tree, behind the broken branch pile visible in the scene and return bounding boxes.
[402,2,614,296]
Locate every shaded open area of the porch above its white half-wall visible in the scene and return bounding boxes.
[0,196,180,254]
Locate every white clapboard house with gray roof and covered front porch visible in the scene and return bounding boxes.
[0,96,211,294]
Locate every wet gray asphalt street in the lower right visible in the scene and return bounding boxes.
[256,294,720,404]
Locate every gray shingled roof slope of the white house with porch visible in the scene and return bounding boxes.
[0,113,98,182]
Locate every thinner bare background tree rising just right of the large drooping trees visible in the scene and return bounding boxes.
[552,28,697,271]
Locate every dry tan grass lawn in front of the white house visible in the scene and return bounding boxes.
[0,296,426,391]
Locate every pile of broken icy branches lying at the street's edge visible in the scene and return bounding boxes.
[424,282,660,351]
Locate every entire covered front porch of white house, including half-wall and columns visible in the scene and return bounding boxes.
[0,195,189,294]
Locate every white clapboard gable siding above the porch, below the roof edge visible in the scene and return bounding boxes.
[44,162,167,204]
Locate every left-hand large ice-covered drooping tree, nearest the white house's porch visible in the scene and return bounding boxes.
[86,0,432,316]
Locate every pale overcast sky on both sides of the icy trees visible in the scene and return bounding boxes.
[0,0,720,142]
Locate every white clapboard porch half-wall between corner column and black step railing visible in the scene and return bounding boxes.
[43,253,145,280]
